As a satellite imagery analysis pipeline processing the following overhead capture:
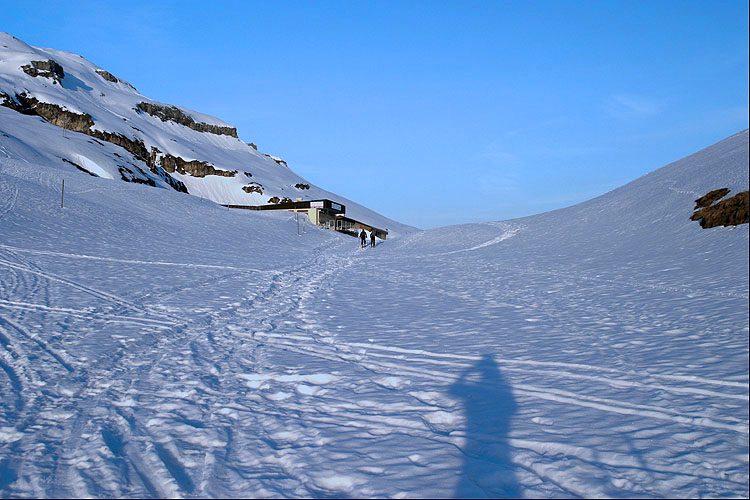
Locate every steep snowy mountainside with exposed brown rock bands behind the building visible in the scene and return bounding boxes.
[0,32,411,234]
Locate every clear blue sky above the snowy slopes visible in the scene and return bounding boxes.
[0,0,748,228]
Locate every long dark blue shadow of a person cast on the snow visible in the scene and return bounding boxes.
[450,354,520,498]
